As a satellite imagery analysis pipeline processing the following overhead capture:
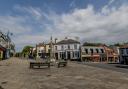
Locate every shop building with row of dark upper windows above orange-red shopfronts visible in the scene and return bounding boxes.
[81,46,106,62]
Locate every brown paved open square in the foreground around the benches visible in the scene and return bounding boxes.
[0,58,128,89]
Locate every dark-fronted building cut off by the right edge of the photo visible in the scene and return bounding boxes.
[119,45,128,64]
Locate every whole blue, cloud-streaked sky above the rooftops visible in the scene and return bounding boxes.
[0,0,128,51]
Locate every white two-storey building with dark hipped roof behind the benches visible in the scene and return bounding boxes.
[54,38,80,60]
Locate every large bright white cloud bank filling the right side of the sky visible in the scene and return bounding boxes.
[46,5,128,43]
